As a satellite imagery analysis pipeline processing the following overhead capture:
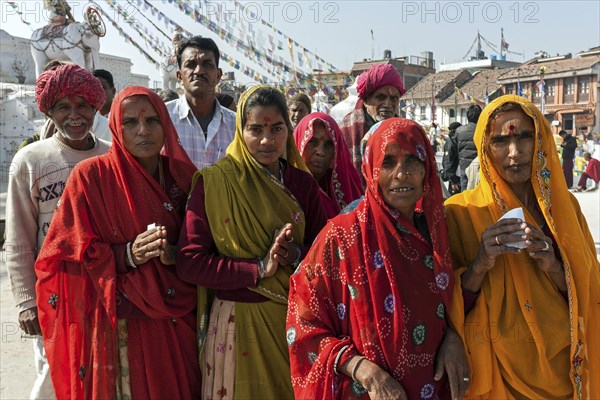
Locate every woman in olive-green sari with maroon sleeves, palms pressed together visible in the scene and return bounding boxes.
[177,86,325,399]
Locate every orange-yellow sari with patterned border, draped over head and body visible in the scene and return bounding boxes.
[446,95,600,399]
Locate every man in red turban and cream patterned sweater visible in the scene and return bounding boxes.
[6,64,110,399]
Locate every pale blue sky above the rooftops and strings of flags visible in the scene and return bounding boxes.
[0,0,600,81]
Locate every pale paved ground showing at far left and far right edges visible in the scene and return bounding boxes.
[0,190,600,399]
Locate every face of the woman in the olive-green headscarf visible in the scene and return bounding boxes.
[243,106,288,168]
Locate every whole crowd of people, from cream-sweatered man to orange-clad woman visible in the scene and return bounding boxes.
[6,32,600,399]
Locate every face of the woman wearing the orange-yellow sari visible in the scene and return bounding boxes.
[486,110,535,185]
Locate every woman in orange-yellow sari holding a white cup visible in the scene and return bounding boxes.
[446,95,600,399]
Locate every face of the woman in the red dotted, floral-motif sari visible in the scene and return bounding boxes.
[378,143,425,217]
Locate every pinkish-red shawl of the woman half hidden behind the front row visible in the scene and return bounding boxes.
[294,112,364,217]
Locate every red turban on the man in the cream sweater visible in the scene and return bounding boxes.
[35,64,104,113]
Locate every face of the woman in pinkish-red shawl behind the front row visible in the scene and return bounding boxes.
[302,120,335,180]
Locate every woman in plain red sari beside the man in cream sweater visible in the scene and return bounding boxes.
[35,86,200,399]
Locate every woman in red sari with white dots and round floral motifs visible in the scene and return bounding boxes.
[286,118,469,399]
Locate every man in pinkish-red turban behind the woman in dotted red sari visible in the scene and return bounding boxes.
[340,64,406,176]
